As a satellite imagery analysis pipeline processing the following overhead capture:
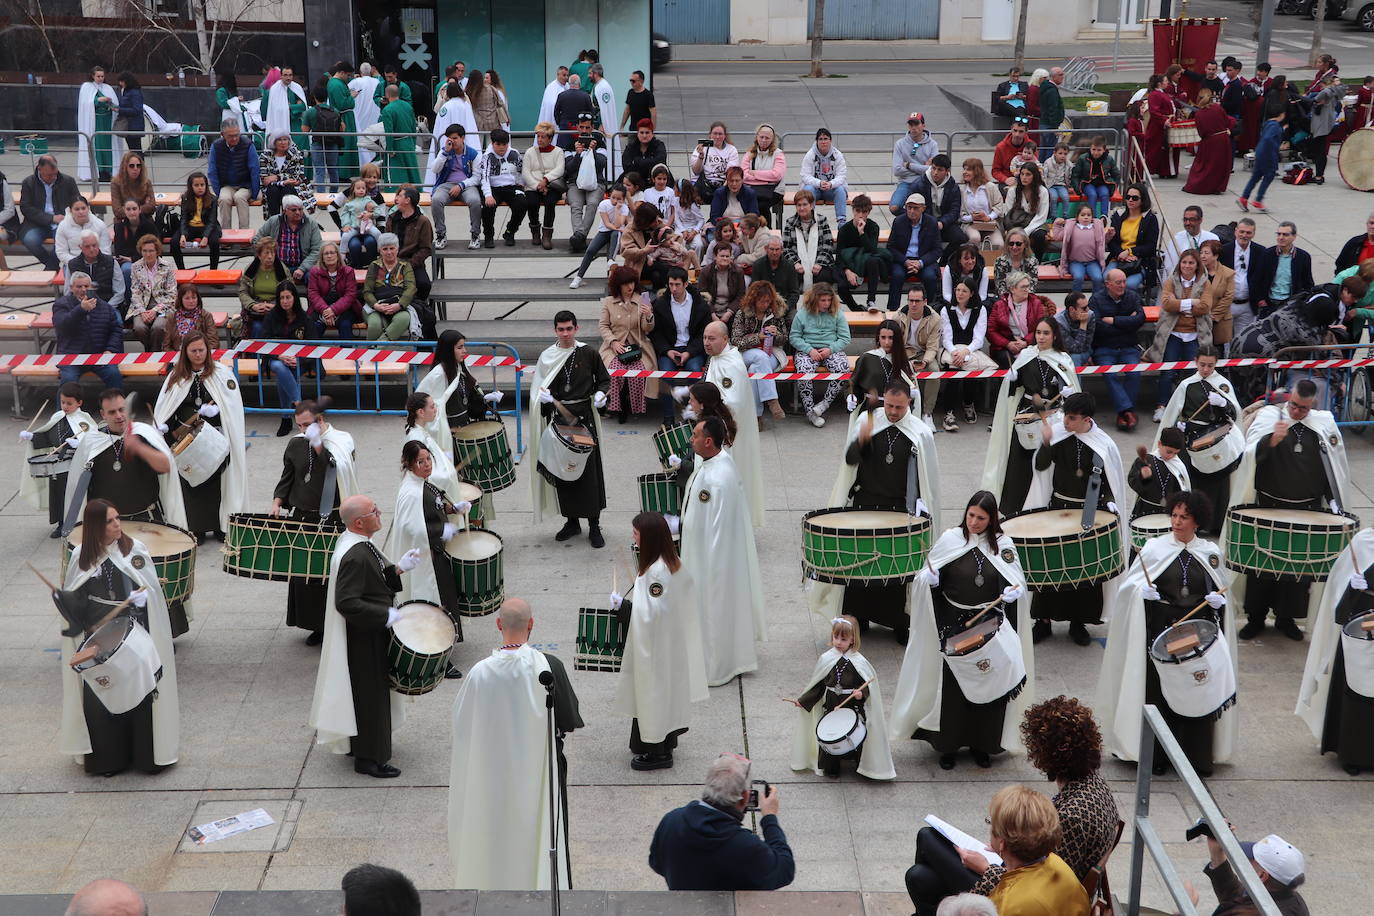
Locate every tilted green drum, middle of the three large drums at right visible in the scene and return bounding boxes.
[1002,509,1125,592]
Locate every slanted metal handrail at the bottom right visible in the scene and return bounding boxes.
[1127,705,1282,916]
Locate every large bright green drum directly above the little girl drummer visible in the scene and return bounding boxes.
[801,508,930,585]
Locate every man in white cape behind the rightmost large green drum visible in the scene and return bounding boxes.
[1223,379,1351,641]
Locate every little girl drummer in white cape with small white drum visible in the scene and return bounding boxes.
[791,614,897,779]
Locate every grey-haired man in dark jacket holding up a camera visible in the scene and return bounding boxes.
[649,754,796,890]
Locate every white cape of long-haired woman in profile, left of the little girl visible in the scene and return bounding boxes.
[614,559,710,744]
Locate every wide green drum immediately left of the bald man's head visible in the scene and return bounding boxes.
[224,512,344,585]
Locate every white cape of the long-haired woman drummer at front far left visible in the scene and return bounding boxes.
[59,538,181,766]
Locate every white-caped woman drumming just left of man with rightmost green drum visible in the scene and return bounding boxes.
[1156,345,1245,534]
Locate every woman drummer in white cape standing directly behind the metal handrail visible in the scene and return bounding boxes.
[1092,493,1239,776]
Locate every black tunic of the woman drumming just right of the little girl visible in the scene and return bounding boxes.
[912,549,1020,754]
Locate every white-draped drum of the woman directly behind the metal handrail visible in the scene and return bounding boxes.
[1150,618,1235,718]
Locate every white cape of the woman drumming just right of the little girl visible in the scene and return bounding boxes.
[889,527,1035,754]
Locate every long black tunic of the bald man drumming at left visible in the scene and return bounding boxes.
[334,541,401,764]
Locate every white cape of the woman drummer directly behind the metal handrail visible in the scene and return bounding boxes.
[1092,534,1241,764]
